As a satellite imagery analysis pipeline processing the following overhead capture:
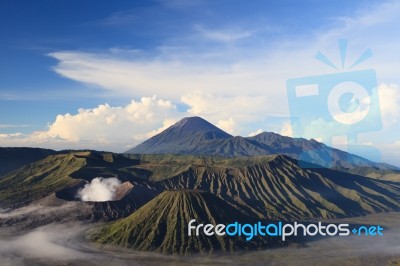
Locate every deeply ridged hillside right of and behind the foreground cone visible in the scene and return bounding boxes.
[157,155,400,220]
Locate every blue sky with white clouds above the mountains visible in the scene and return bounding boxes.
[0,0,400,163]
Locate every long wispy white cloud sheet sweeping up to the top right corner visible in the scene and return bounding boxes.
[49,2,400,104]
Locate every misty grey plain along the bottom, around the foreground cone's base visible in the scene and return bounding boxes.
[0,213,400,266]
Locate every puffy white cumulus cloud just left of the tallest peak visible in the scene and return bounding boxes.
[42,96,176,141]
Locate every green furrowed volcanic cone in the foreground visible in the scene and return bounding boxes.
[91,190,282,254]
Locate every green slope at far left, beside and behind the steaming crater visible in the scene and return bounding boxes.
[0,151,144,211]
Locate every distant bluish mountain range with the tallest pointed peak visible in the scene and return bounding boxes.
[125,117,400,171]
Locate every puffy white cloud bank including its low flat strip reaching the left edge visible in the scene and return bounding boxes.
[0,96,180,151]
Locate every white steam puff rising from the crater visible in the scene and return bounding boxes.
[77,177,121,201]
